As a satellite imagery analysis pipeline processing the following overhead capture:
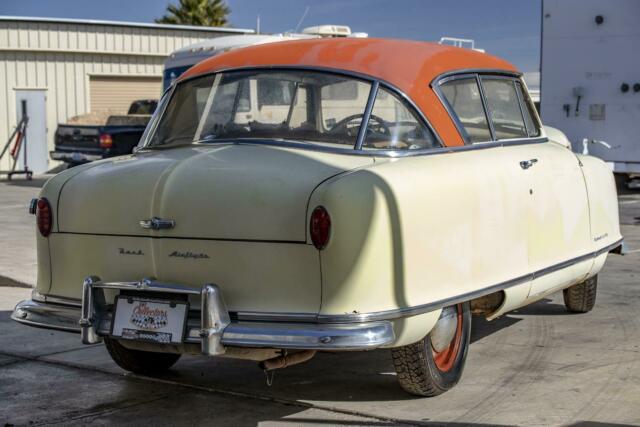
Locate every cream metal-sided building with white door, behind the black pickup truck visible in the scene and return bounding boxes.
[0,16,254,173]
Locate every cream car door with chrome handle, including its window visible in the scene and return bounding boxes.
[481,76,591,296]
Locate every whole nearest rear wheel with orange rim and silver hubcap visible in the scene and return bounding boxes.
[392,302,471,397]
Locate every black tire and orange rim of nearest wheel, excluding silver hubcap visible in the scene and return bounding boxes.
[392,303,471,397]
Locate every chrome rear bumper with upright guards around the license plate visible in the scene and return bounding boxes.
[11,277,395,356]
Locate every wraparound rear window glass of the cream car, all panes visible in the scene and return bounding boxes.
[145,70,434,149]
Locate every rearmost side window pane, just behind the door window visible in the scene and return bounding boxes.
[440,77,491,143]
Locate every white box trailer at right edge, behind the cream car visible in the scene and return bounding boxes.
[540,0,640,182]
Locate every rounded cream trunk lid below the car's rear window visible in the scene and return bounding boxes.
[57,144,373,242]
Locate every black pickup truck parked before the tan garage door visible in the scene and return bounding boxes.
[50,99,158,166]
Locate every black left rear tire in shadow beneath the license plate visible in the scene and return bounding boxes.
[104,337,180,375]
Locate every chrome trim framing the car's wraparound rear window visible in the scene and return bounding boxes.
[138,65,444,157]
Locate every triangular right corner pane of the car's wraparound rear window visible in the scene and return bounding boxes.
[362,88,440,150]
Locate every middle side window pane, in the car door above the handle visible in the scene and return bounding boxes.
[482,77,528,140]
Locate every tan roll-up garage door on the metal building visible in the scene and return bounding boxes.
[89,76,162,114]
